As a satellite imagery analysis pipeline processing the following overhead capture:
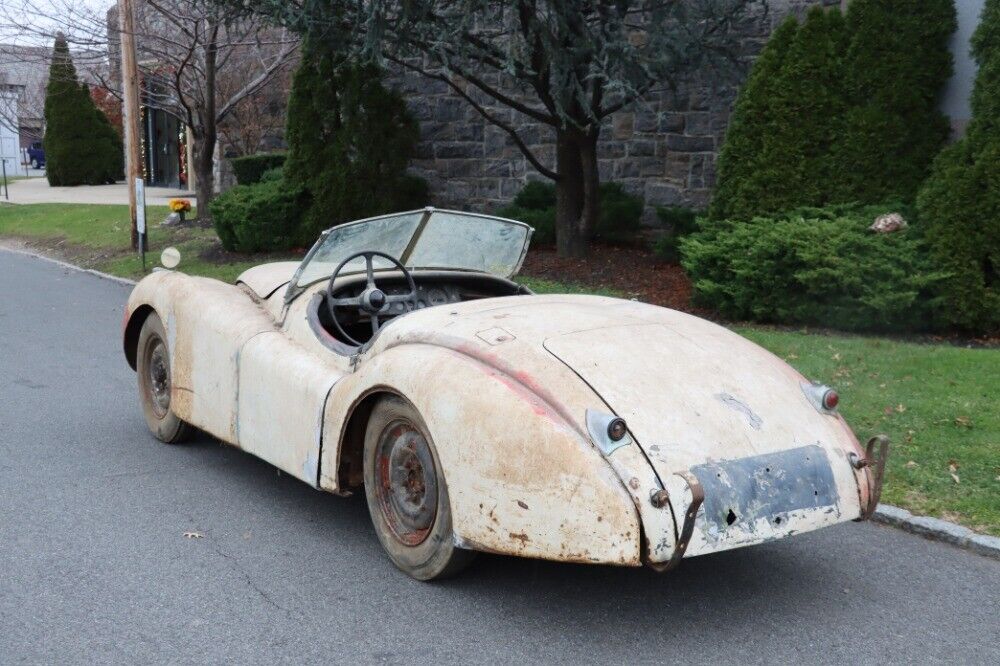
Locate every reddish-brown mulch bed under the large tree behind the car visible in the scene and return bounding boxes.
[521,245,698,312]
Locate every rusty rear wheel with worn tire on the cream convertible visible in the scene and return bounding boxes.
[365,397,475,580]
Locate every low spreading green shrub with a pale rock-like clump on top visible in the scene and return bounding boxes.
[681,200,943,331]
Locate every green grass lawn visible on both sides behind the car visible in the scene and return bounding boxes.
[0,204,1000,536]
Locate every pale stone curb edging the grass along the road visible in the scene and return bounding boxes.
[0,245,1000,560]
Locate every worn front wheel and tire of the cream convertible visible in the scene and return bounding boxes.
[135,312,191,444]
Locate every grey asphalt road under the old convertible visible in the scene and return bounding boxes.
[0,250,1000,664]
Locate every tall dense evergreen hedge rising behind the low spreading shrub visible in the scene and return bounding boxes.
[709,0,955,219]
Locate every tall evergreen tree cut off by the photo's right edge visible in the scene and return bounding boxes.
[917,0,1000,333]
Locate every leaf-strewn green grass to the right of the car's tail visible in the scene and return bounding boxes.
[736,327,1000,536]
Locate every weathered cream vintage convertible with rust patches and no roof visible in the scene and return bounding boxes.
[123,208,888,580]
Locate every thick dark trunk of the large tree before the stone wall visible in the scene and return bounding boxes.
[556,128,601,258]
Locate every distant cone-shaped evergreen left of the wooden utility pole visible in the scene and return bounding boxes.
[44,34,124,185]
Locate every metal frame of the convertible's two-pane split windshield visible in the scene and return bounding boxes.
[285,206,535,303]
